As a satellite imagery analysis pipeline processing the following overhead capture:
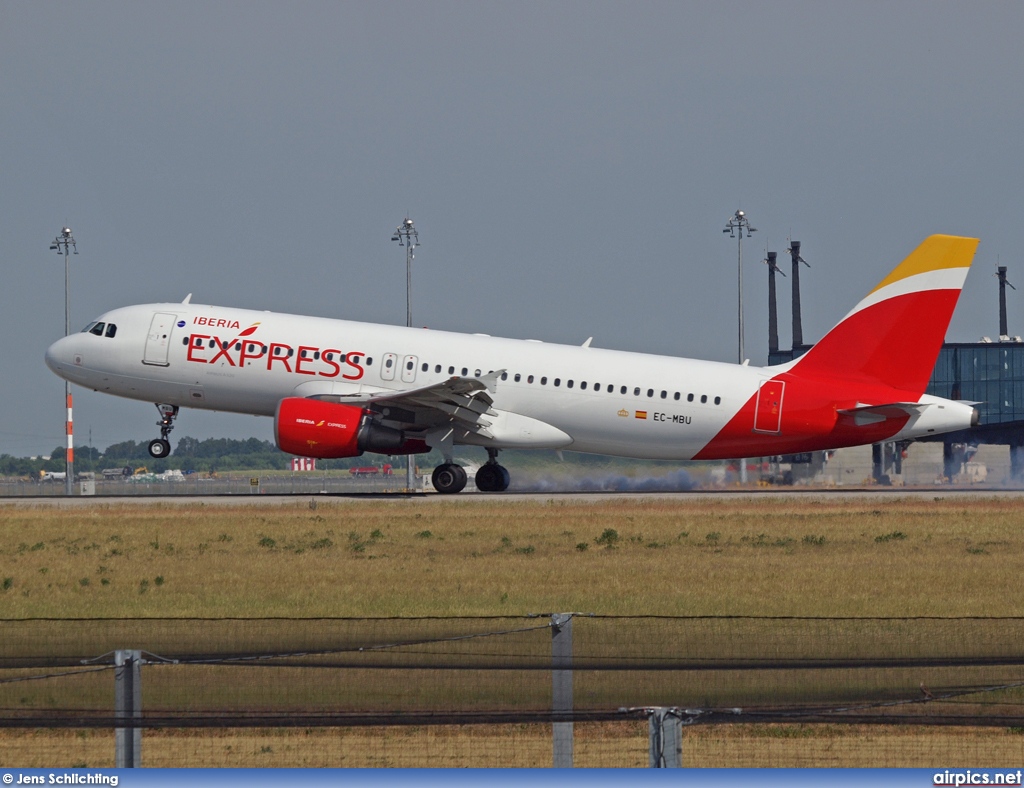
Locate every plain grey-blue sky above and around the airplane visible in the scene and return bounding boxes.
[0,0,1024,454]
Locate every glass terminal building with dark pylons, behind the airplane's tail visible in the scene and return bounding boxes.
[765,242,1024,484]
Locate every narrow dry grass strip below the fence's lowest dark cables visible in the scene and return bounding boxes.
[6,723,1024,769]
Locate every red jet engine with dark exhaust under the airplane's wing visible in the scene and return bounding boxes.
[273,397,429,459]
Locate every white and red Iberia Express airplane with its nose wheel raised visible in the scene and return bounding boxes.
[46,235,978,493]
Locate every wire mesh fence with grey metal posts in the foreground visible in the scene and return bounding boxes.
[6,614,1024,767]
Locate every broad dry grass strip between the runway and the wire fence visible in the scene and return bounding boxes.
[0,498,1024,617]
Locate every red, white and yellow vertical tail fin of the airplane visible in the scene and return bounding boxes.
[791,235,978,395]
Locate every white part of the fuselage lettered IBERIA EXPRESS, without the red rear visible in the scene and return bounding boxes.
[41,304,766,459]
